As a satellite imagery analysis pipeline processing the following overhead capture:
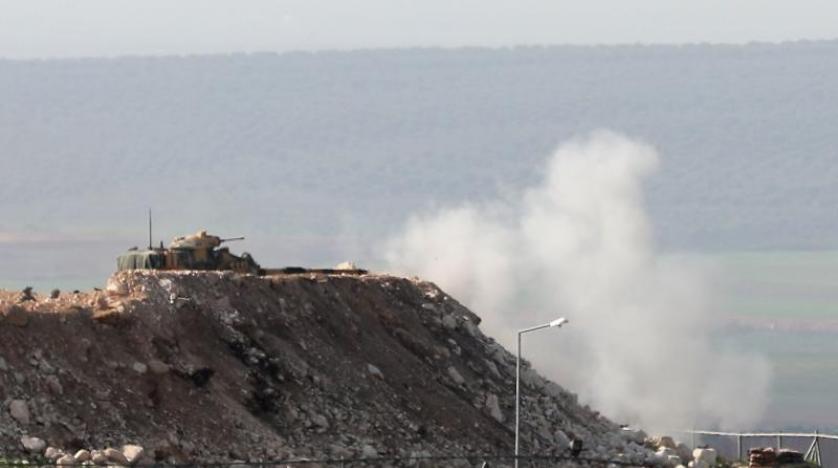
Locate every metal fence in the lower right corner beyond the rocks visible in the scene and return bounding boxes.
[673,430,838,468]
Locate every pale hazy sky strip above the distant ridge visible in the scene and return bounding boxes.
[0,0,838,58]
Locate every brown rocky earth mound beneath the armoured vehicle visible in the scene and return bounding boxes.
[0,272,650,462]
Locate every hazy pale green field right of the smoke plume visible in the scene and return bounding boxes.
[702,251,838,431]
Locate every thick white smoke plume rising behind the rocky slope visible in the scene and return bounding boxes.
[385,132,770,431]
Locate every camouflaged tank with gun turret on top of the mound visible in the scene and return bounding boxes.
[116,230,263,274]
